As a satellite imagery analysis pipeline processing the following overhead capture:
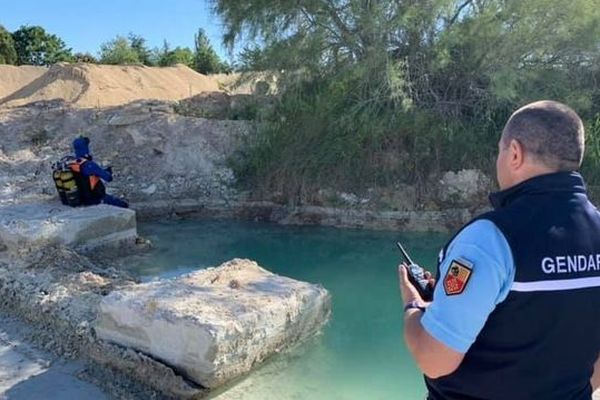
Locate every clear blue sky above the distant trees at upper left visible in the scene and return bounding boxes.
[0,0,239,60]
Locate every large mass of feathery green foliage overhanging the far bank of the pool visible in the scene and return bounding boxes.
[214,0,600,201]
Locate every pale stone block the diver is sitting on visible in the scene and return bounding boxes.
[0,203,137,251]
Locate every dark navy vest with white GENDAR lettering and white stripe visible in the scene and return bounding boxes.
[425,172,600,400]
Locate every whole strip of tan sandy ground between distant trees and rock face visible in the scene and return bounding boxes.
[0,63,275,108]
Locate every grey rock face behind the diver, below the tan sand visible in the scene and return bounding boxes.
[0,101,253,208]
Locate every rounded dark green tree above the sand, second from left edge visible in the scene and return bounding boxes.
[12,26,72,65]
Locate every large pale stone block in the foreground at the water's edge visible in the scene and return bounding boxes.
[96,259,331,388]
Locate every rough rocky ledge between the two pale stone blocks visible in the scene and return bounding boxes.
[0,246,207,400]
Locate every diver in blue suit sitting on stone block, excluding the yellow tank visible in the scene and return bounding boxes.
[69,136,129,208]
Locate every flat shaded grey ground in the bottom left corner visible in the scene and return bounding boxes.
[0,314,108,400]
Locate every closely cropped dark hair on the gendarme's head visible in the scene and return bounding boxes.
[502,100,585,171]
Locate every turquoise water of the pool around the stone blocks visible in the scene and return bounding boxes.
[123,221,447,400]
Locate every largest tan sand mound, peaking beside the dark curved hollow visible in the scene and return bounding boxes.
[0,63,220,108]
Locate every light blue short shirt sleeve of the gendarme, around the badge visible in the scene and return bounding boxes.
[421,220,514,353]
